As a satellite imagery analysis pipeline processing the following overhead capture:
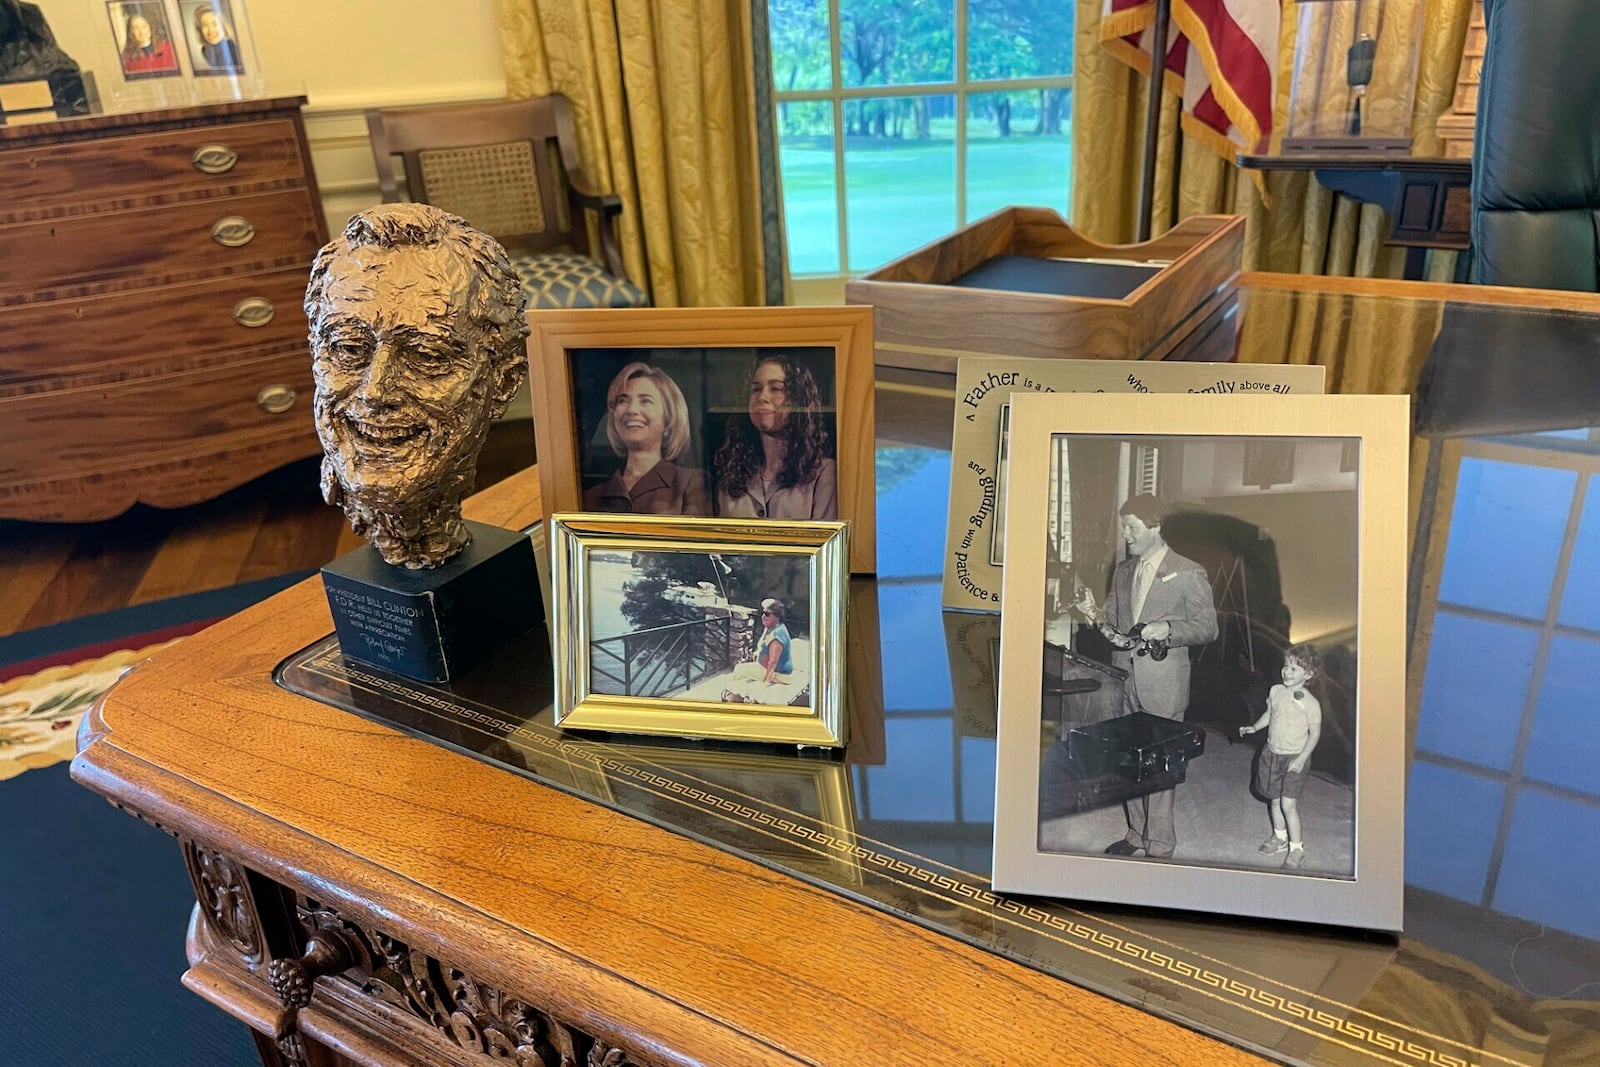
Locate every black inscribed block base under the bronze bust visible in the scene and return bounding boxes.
[322,522,544,681]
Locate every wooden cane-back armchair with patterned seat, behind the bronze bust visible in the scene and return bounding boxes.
[366,94,650,309]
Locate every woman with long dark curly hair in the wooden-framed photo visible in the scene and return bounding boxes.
[712,355,838,520]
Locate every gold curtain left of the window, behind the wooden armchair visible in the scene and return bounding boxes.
[499,0,762,307]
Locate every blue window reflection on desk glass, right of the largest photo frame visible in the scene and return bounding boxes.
[1406,430,1600,937]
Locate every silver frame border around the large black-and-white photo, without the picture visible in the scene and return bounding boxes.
[994,394,1408,931]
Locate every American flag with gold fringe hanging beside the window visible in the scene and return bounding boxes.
[1099,0,1282,158]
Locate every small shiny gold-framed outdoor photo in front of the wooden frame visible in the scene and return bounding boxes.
[550,514,848,749]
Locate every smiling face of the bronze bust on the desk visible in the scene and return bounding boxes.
[312,248,493,510]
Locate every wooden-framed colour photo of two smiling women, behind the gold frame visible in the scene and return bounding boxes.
[528,307,877,574]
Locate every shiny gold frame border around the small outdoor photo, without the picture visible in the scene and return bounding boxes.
[550,514,850,749]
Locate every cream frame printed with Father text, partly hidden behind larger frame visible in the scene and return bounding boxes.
[944,357,1326,611]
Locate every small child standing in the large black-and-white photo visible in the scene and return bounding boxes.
[1238,645,1322,870]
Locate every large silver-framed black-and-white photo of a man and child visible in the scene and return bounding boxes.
[994,394,1408,931]
